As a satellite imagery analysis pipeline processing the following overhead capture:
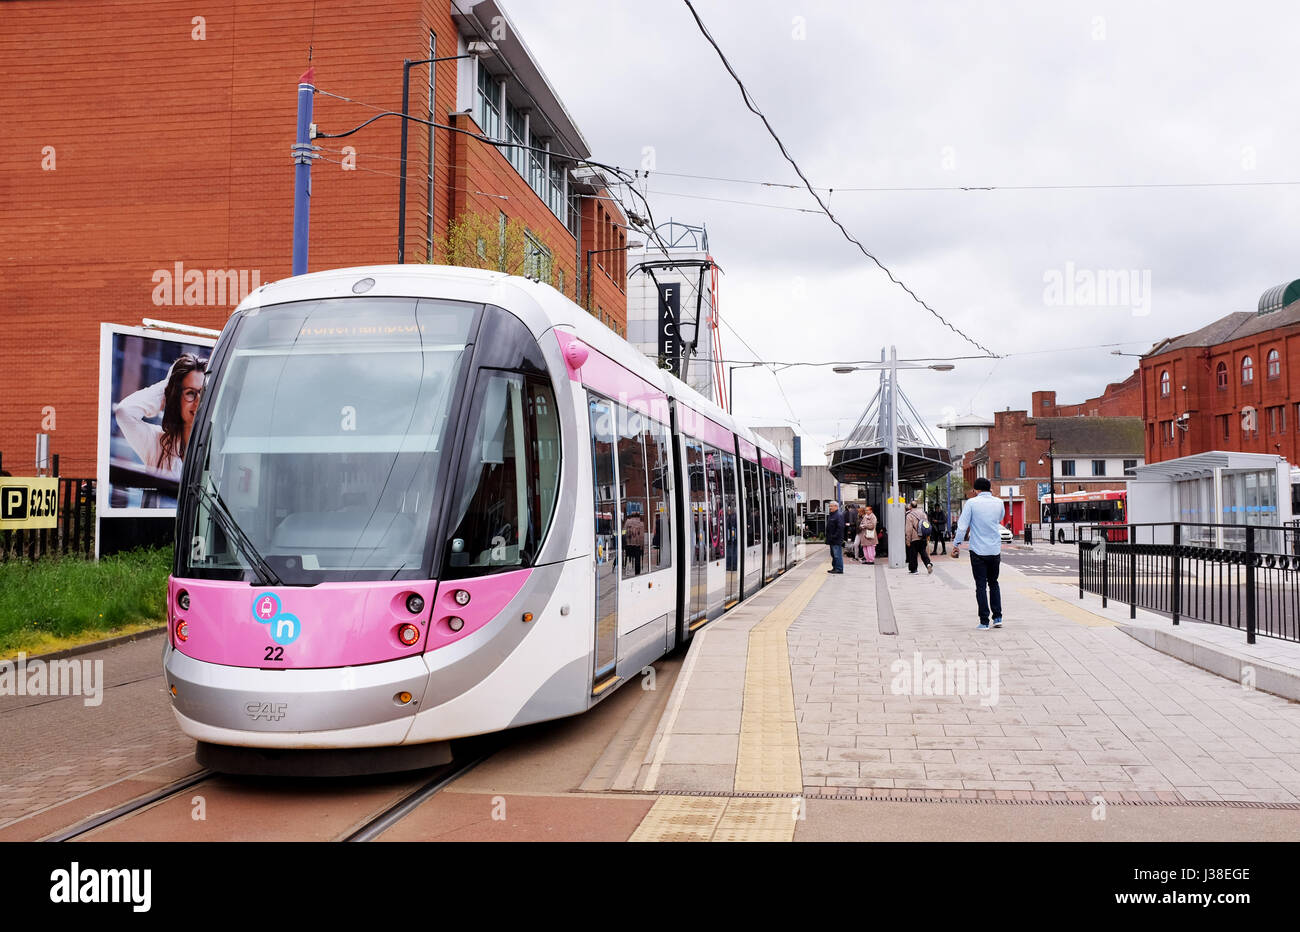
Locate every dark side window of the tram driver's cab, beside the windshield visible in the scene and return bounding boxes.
[447,372,559,576]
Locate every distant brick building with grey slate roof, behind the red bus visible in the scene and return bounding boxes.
[962,372,1143,534]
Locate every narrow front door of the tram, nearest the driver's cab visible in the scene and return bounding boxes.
[588,398,620,688]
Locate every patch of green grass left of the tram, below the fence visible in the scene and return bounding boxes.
[0,547,172,653]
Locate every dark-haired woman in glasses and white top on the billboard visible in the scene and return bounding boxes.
[113,352,208,482]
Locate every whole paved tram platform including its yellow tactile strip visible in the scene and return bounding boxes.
[611,547,1300,841]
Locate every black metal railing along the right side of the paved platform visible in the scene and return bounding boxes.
[1078,524,1300,643]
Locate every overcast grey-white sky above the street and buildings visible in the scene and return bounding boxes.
[503,0,1300,461]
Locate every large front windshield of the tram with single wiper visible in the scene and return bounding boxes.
[178,298,478,585]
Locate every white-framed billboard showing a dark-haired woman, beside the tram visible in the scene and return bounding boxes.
[96,324,215,517]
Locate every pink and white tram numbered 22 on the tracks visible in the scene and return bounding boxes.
[164,265,798,772]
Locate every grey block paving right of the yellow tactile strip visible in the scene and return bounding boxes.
[788,556,1300,803]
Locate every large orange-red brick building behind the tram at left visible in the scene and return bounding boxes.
[0,0,627,476]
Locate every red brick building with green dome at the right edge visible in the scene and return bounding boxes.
[1141,282,1300,463]
